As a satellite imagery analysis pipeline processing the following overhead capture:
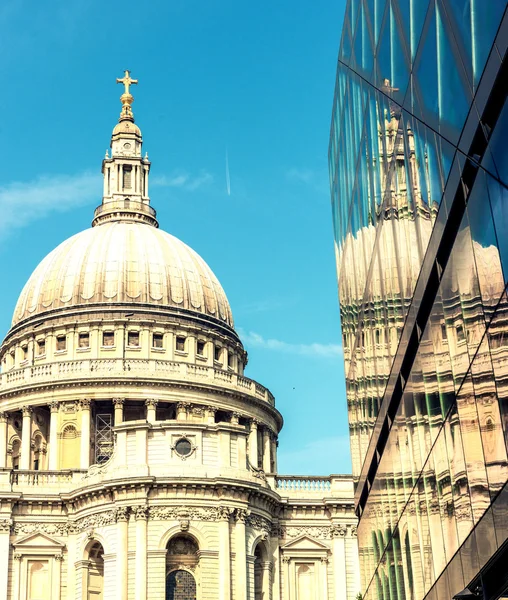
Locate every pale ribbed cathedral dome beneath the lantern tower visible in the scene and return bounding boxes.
[12,220,233,327]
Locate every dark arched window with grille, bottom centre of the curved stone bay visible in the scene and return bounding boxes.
[166,535,199,600]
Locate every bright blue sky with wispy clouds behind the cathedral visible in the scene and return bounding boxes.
[0,0,351,474]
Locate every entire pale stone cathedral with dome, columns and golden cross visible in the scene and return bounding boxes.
[0,72,360,600]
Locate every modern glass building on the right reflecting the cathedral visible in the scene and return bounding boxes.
[329,0,508,600]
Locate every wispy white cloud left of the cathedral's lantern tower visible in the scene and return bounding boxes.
[0,172,102,234]
